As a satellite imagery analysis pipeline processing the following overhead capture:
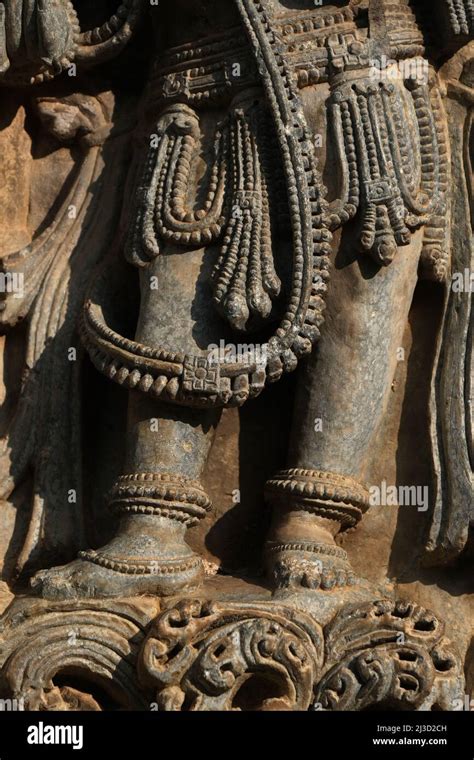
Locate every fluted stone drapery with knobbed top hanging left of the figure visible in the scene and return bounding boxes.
[0,92,128,573]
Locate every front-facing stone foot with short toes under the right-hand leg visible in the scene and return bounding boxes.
[266,541,357,591]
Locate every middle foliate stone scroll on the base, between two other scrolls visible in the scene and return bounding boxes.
[139,600,323,711]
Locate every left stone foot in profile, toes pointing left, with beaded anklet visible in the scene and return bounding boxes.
[31,518,204,600]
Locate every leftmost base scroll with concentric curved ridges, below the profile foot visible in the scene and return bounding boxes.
[0,598,160,711]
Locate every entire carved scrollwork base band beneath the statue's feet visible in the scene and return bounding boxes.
[0,597,464,711]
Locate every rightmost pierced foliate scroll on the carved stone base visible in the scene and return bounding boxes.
[313,601,463,711]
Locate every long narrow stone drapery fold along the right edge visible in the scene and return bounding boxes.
[425,42,474,565]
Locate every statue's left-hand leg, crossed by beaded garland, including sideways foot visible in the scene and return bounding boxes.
[32,251,219,598]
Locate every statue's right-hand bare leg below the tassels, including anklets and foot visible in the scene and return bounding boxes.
[266,236,420,589]
